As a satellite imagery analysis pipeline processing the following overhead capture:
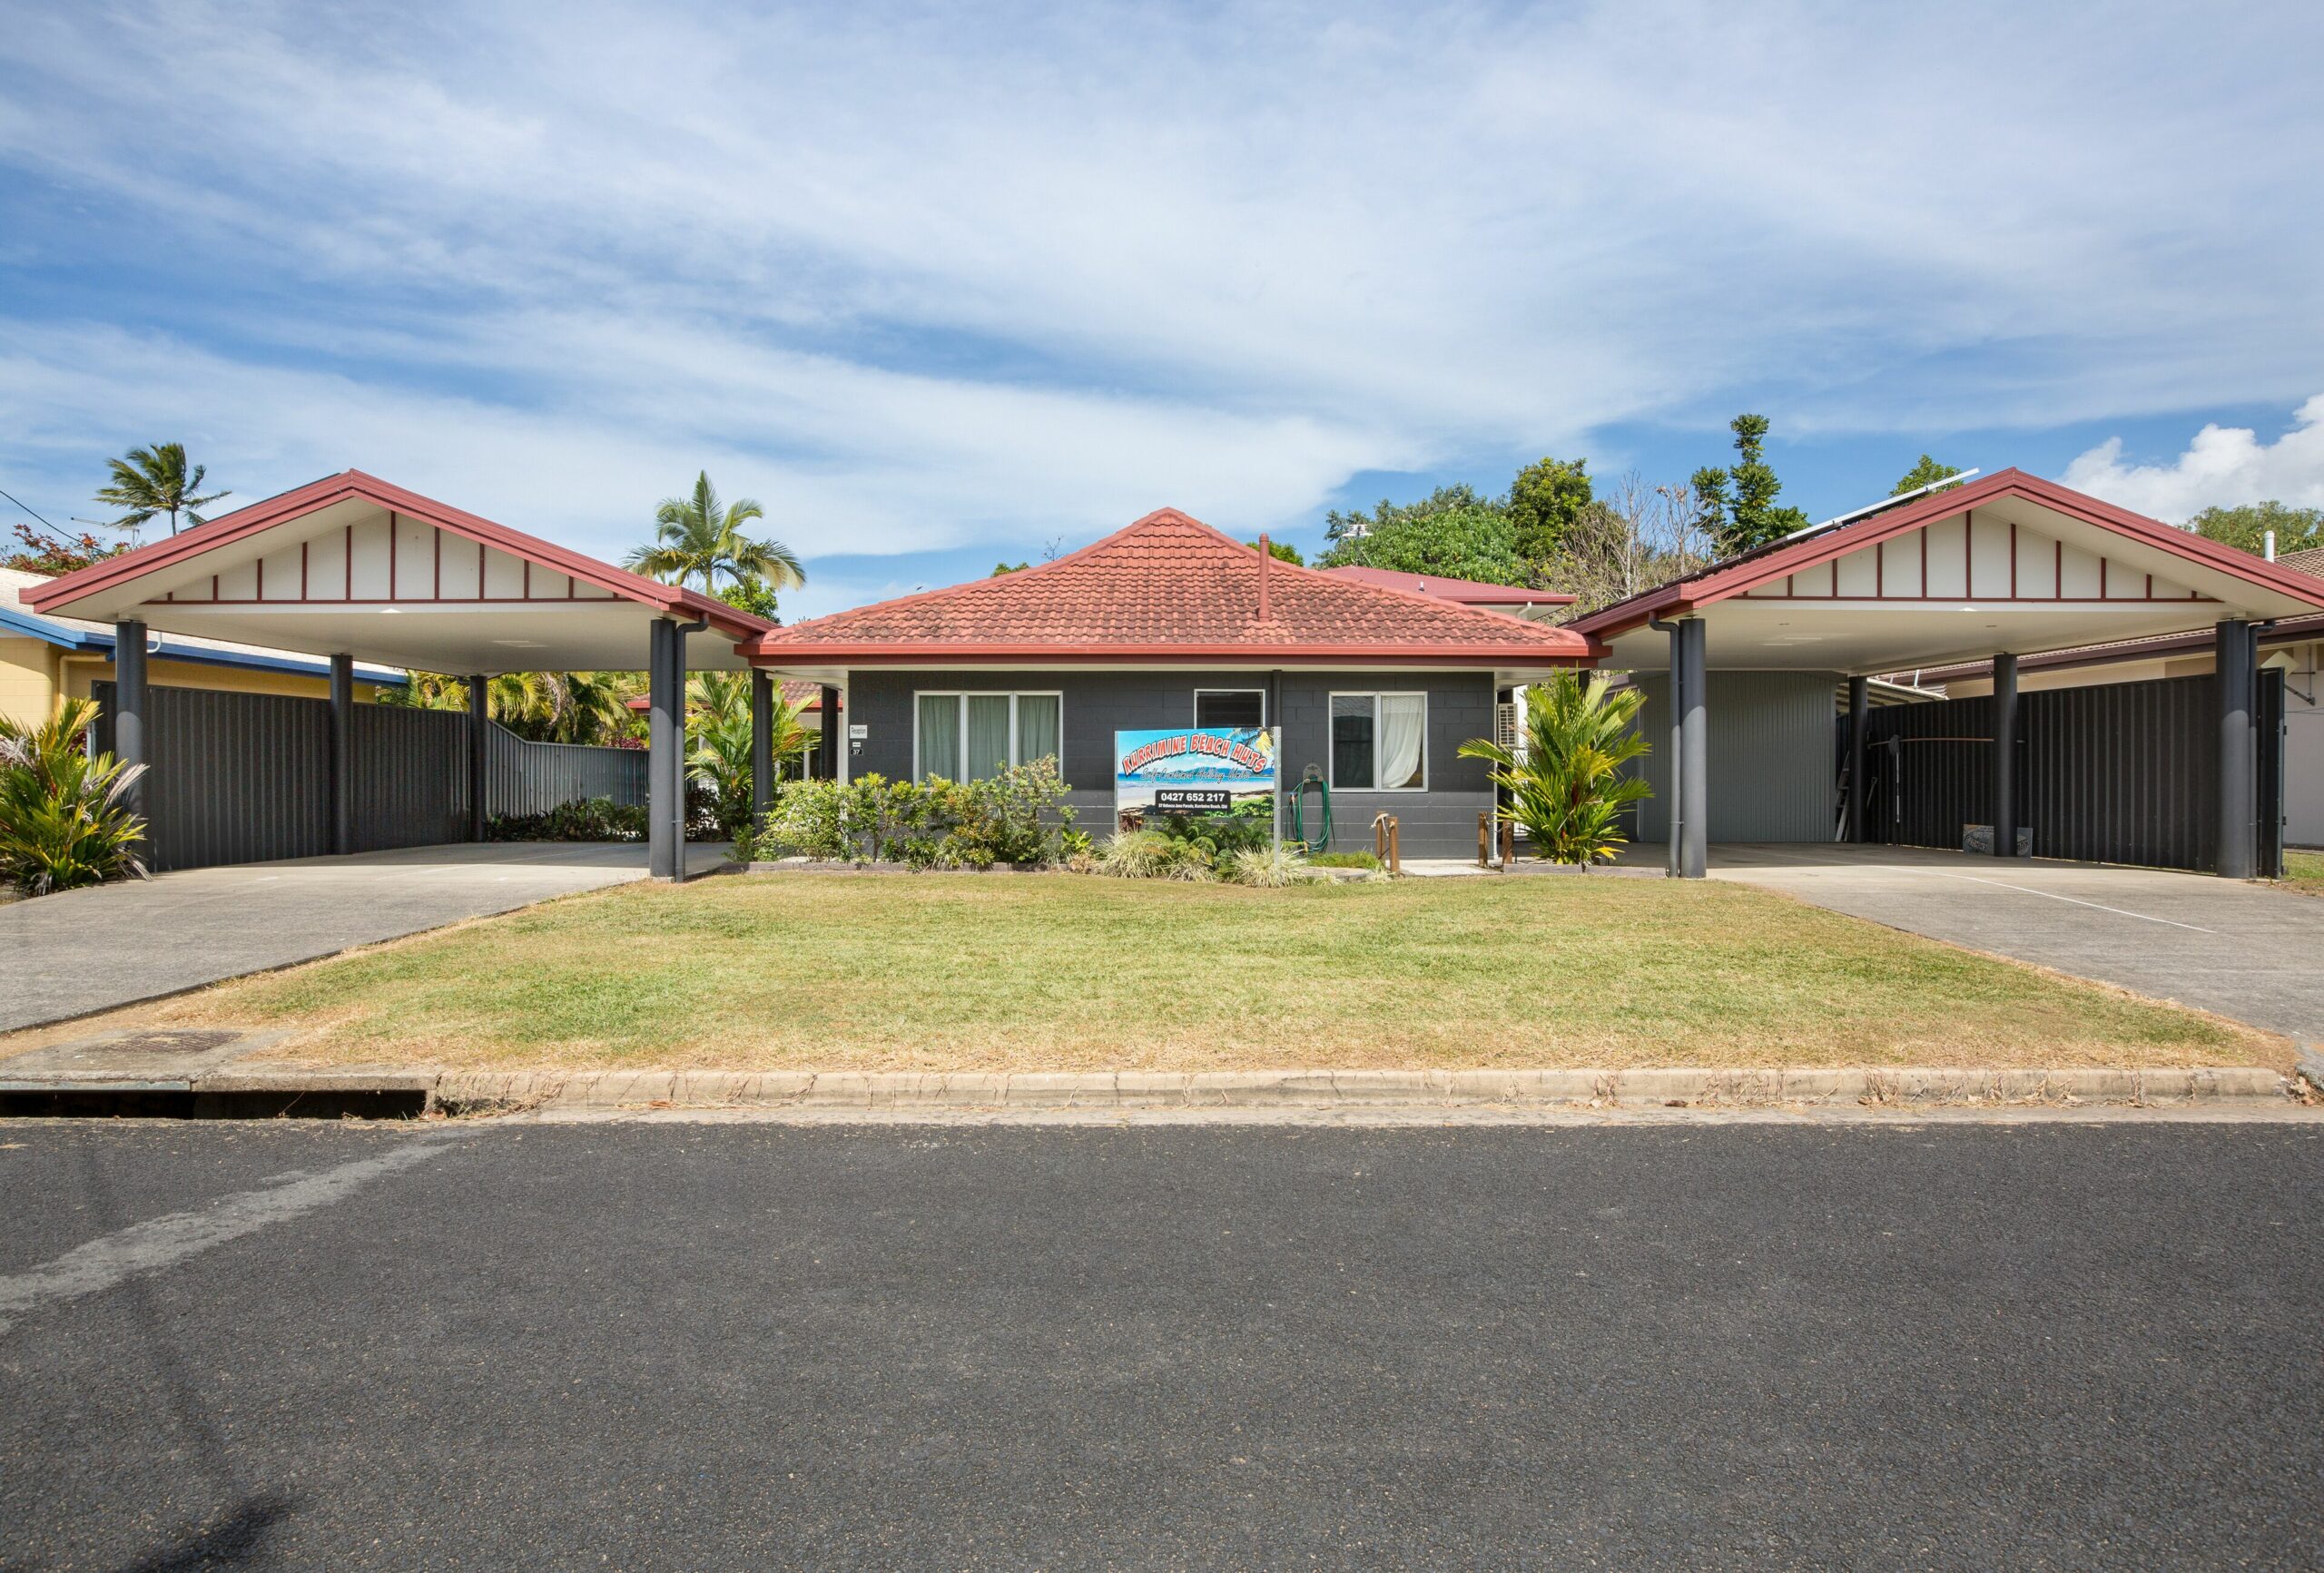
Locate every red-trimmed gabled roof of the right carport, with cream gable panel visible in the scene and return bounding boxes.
[1571,469,2324,673]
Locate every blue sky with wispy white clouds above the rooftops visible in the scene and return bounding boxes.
[0,0,2324,615]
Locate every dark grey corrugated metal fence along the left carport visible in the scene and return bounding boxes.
[93,683,646,871]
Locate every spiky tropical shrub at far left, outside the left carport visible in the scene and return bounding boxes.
[0,700,146,895]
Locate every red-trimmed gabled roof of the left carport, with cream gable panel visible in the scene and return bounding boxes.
[24,469,772,672]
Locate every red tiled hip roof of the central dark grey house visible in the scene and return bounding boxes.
[737,509,1597,667]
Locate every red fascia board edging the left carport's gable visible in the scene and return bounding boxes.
[24,469,773,639]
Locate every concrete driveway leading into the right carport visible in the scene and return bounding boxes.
[1691,846,2324,1041]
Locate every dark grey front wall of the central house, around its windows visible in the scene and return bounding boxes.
[846,672,1492,858]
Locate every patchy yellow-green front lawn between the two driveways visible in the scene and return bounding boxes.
[135,873,2284,1069]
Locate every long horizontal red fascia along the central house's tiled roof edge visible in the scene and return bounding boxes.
[734,639,1606,667]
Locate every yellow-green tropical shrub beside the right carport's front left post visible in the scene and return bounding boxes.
[1460,672,1652,867]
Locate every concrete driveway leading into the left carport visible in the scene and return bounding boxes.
[0,841,727,1032]
